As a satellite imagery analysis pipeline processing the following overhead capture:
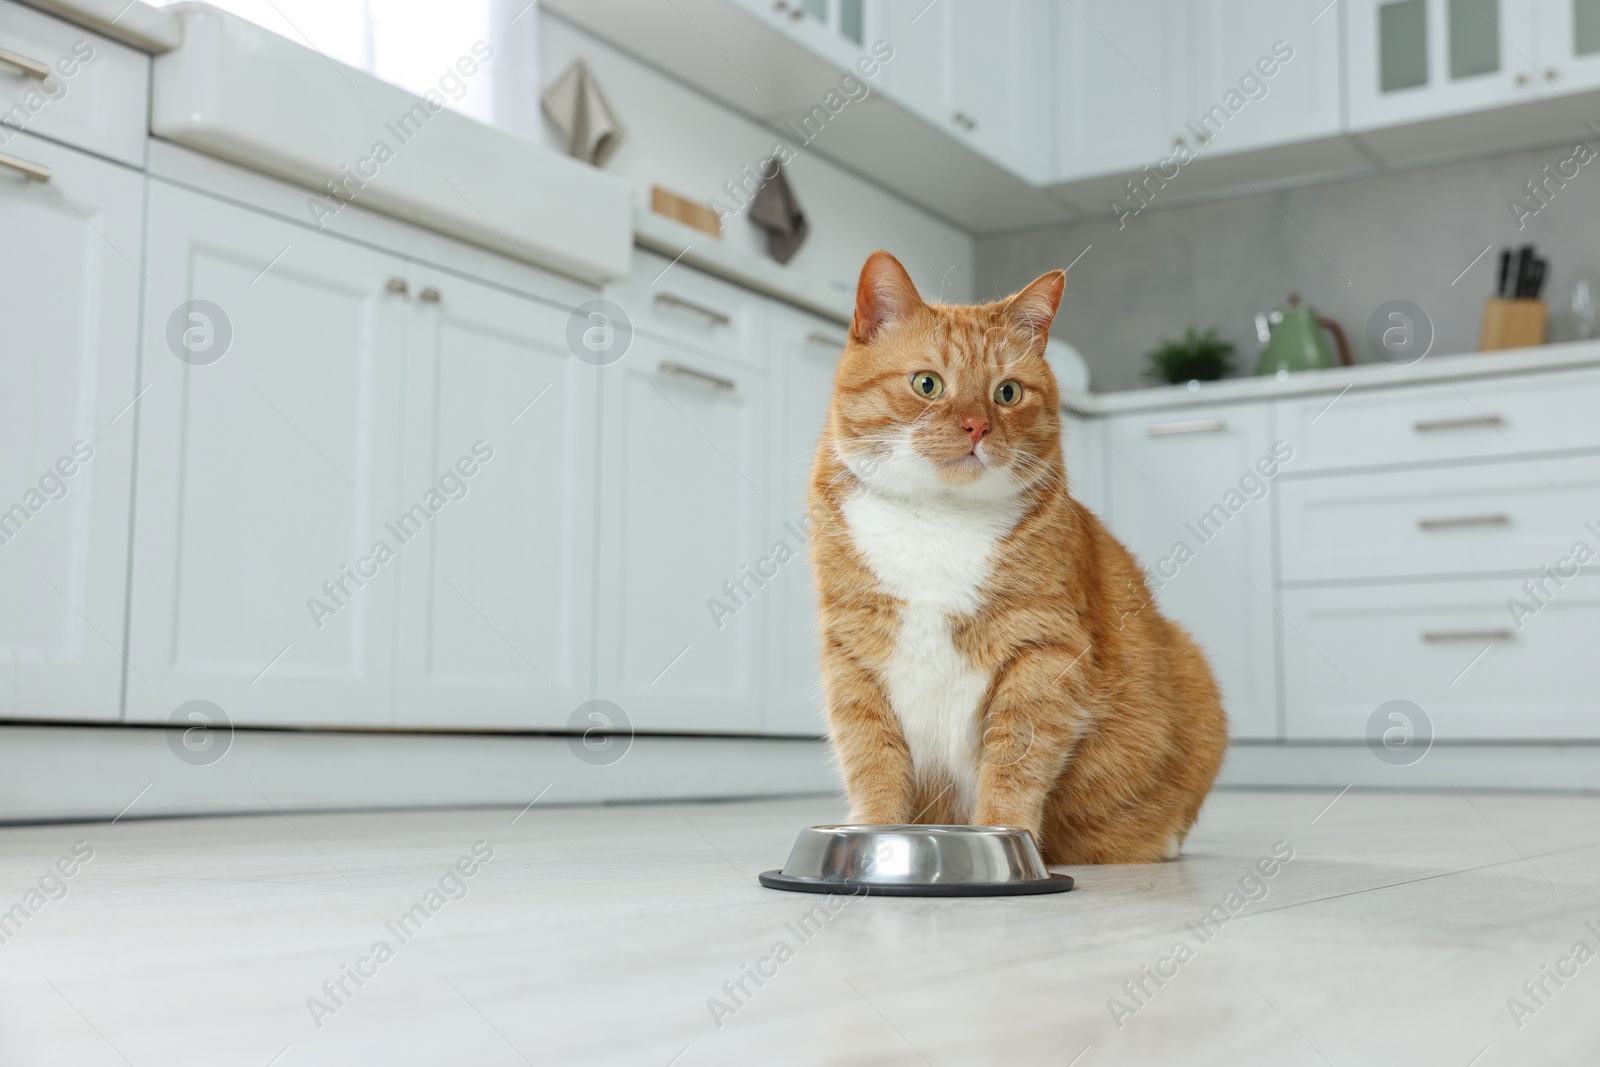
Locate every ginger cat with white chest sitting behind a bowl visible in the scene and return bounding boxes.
[811,251,1227,864]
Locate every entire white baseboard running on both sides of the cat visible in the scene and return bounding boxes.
[9,725,1600,822]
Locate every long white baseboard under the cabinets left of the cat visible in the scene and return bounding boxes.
[0,725,838,822]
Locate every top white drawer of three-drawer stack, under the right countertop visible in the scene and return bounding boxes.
[1278,369,1600,472]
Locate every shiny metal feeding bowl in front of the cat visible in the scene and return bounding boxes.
[762,825,1072,896]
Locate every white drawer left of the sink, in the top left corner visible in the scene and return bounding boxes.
[0,0,150,166]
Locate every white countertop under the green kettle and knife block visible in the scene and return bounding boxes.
[1061,341,1600,416]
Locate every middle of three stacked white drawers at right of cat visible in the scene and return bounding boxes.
[1278,456,1600,582]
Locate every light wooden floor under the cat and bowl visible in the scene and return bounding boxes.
[0,792,1600,1067]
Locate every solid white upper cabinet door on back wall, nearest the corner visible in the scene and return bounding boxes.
[1056,0,1190,181]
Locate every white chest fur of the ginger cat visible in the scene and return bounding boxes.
[845,490,1021,816]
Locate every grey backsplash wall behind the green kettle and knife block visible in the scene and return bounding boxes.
[978,138,1600,392]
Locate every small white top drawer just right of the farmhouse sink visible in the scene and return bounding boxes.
[606,250,765,368]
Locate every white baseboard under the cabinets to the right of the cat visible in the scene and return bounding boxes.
[1218,742,1600,792]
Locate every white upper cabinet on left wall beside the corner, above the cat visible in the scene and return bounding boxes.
[883,0,1054,182]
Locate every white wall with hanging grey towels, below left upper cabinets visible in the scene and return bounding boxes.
[539,11,974,301]
